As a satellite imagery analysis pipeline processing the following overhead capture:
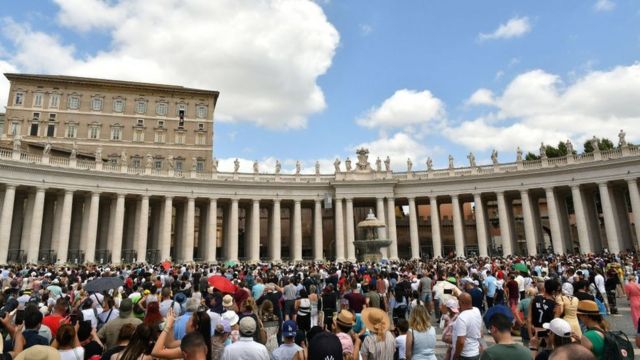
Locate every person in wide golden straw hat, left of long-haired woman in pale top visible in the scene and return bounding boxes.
[354,308,396,360]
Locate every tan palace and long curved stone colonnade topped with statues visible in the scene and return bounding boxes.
[0,74,640,263]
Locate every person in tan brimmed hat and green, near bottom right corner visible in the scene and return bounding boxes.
[572,300,608,360]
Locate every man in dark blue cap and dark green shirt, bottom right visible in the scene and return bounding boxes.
[480,313,531,360]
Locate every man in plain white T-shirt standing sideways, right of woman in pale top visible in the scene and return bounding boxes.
[452,293,482,360]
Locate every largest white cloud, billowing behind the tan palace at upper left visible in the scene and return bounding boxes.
[0,0,339,129]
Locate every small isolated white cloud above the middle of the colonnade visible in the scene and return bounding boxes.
[356,89,445,128]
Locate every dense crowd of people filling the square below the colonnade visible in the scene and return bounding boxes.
[0,253,640,360]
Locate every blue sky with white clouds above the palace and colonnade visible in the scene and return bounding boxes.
[0,0,640,172]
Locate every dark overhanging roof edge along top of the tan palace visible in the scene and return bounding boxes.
[4,73,220,101]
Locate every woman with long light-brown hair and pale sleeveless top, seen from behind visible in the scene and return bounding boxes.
[406,305,436,360]
